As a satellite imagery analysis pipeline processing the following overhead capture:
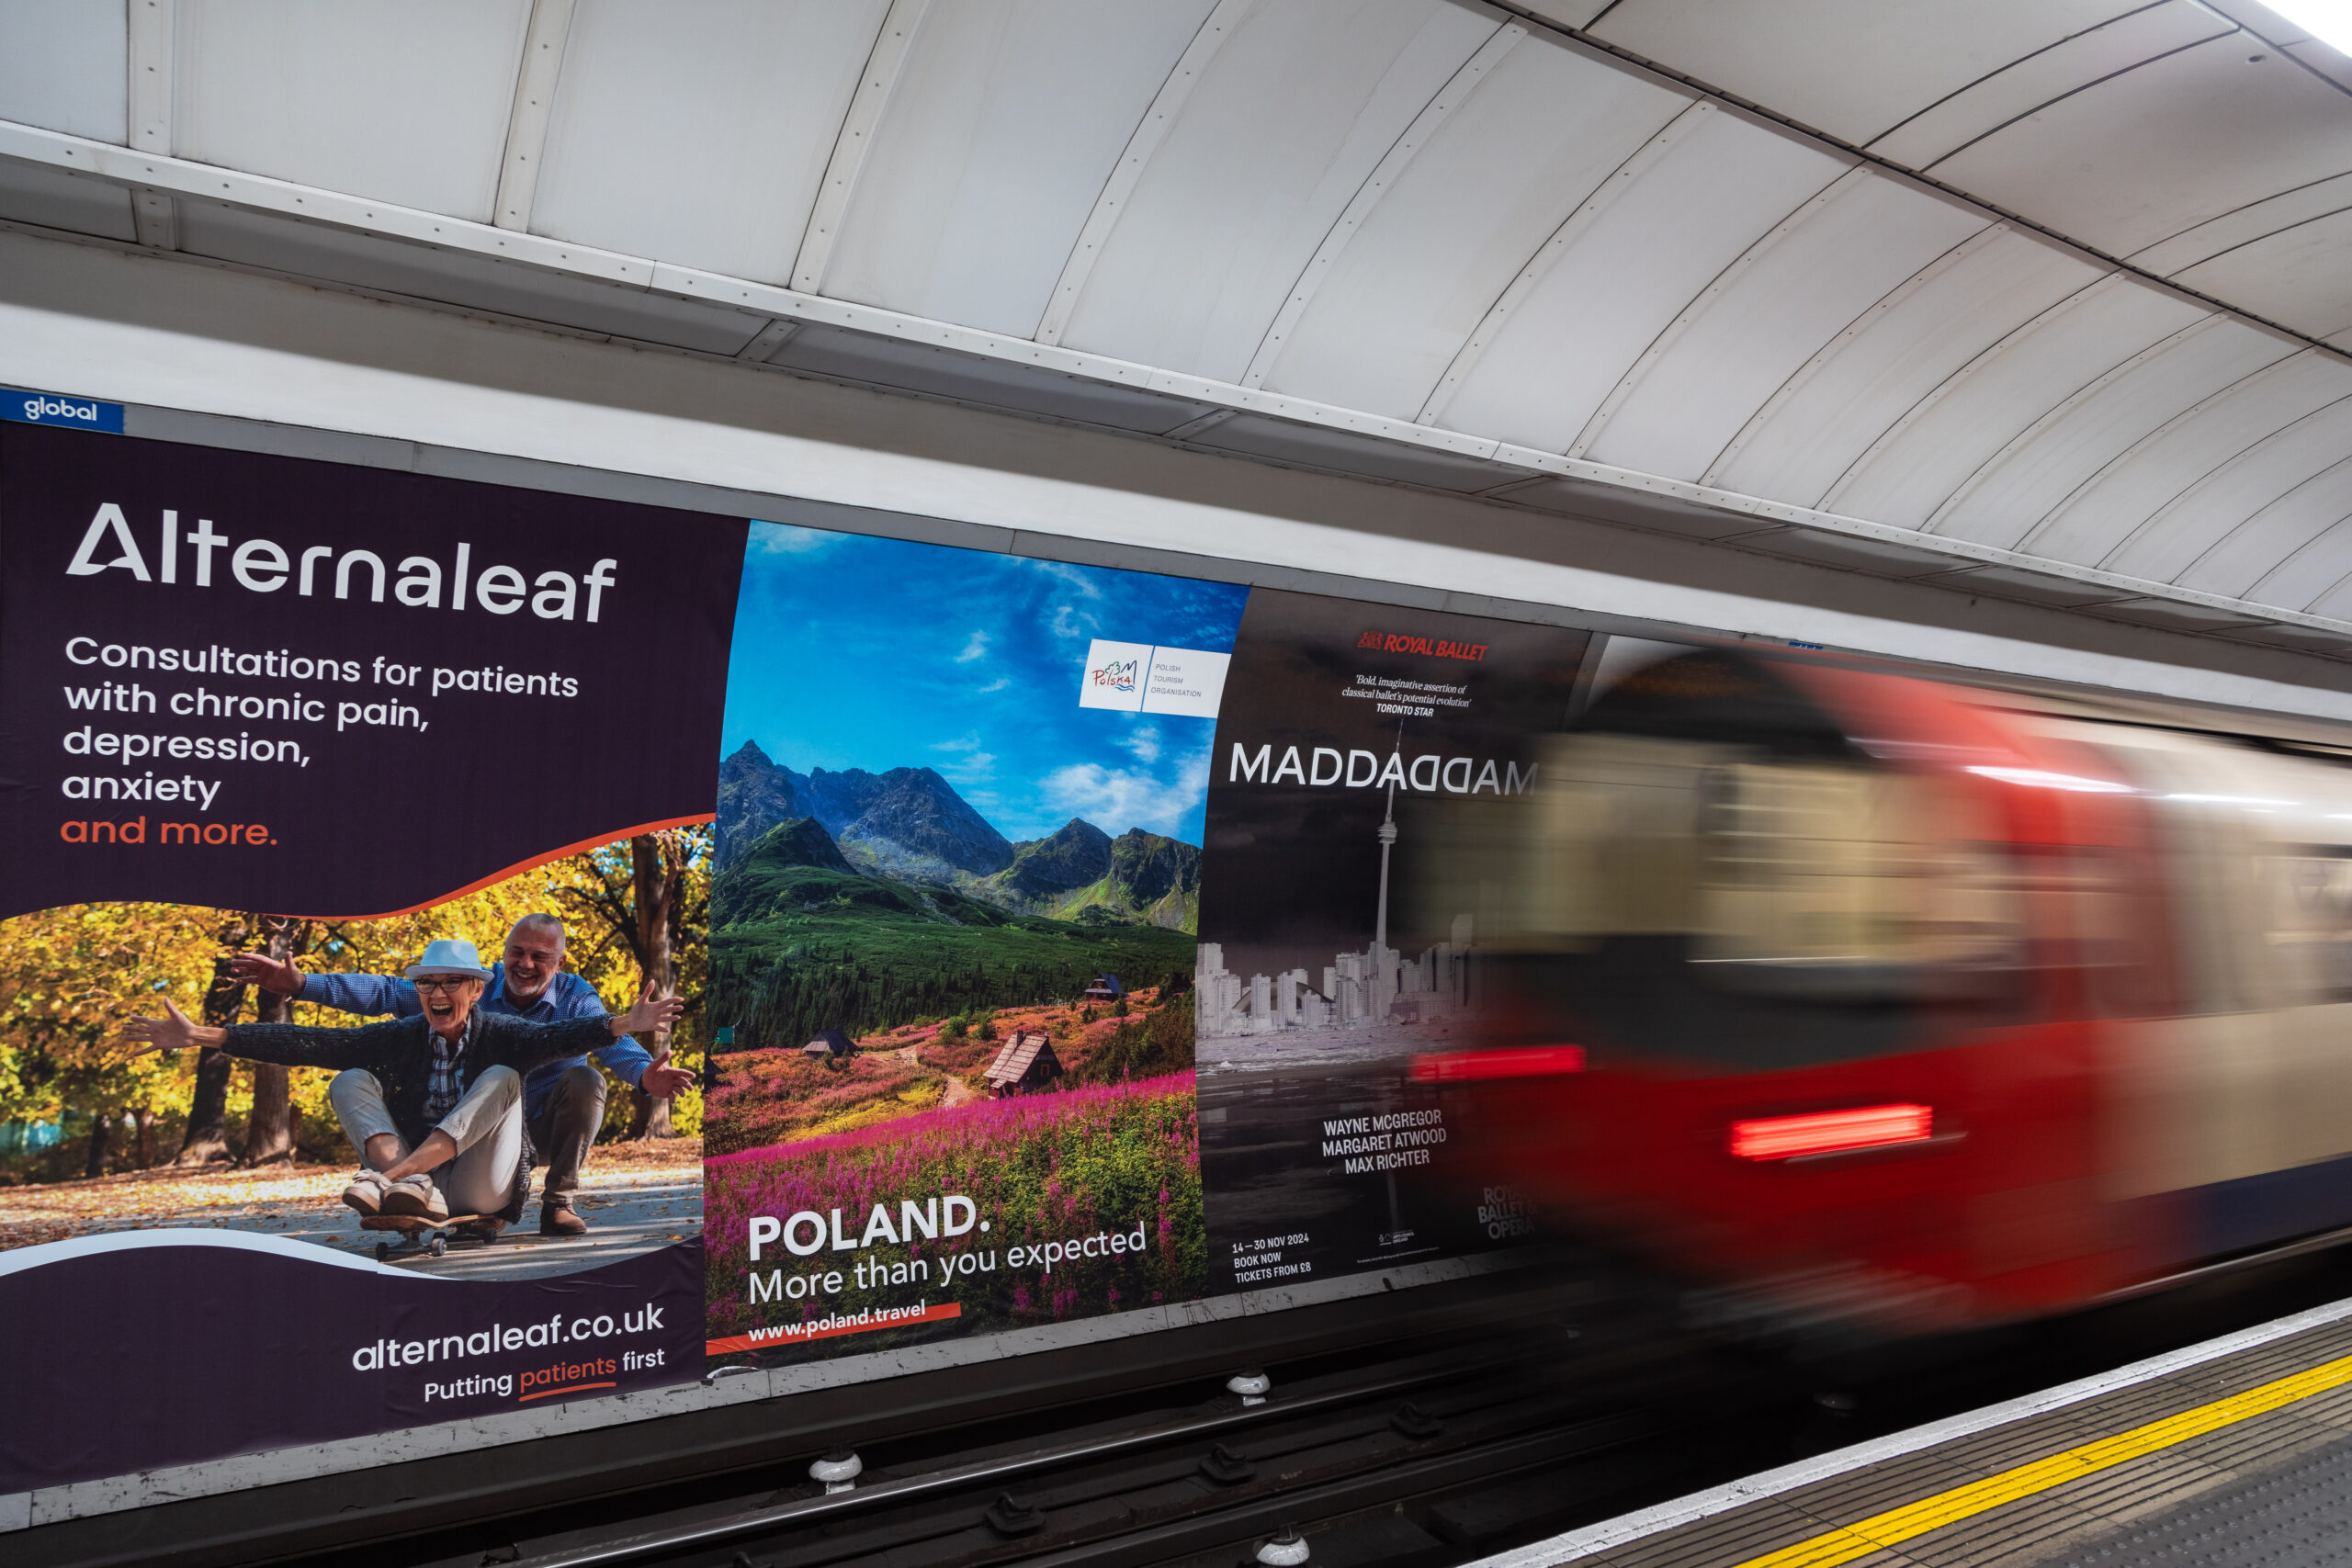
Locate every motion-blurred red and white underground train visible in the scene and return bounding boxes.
[1414,651,2352,1331]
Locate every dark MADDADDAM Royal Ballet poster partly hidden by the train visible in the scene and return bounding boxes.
[1194,590,1585,1288]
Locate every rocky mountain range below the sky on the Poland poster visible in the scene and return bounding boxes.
[718,740,1200,931]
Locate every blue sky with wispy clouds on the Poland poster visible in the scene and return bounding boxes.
[722,522,1249,844]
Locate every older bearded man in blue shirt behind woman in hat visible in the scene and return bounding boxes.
[231,915,694,1236]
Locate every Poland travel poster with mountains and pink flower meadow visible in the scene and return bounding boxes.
[706,525,1247,1361]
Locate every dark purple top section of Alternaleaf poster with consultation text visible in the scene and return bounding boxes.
[0,425,746,917]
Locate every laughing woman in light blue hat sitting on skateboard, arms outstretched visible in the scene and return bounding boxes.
[125,941,684,1239]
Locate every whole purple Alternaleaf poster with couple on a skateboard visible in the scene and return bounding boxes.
[0,425,746,1493]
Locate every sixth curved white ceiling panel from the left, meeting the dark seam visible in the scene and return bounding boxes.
[1265,35,1691,419]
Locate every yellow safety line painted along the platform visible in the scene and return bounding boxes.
[1738,1357,2352,1568]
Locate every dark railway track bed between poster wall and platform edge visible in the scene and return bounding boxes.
[280,1253,2352,1568]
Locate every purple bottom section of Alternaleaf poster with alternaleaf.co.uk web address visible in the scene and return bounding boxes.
[0,1232,703,1493]
